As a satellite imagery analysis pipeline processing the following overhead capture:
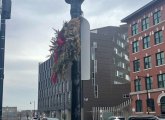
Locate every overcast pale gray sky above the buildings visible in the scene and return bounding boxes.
[3,0,151,110]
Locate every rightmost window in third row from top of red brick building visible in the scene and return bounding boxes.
[156,52,164,66]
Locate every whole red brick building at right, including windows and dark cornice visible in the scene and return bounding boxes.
[121,0,165,115]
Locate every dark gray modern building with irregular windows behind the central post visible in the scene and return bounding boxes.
[38,25,130,120]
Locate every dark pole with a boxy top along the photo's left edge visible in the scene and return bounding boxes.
[0,0,11,120]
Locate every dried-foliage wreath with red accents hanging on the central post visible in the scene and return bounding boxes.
[50,18,81,83]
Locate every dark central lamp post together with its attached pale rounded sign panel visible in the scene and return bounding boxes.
[65,0,90,120]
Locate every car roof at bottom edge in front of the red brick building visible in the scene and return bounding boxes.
[128,115,160,120]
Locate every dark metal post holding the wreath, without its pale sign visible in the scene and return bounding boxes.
[65,0,84,120]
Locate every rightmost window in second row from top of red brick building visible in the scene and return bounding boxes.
[154,30,163,44]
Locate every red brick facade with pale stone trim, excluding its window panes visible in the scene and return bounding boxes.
[124,0,165,115]
